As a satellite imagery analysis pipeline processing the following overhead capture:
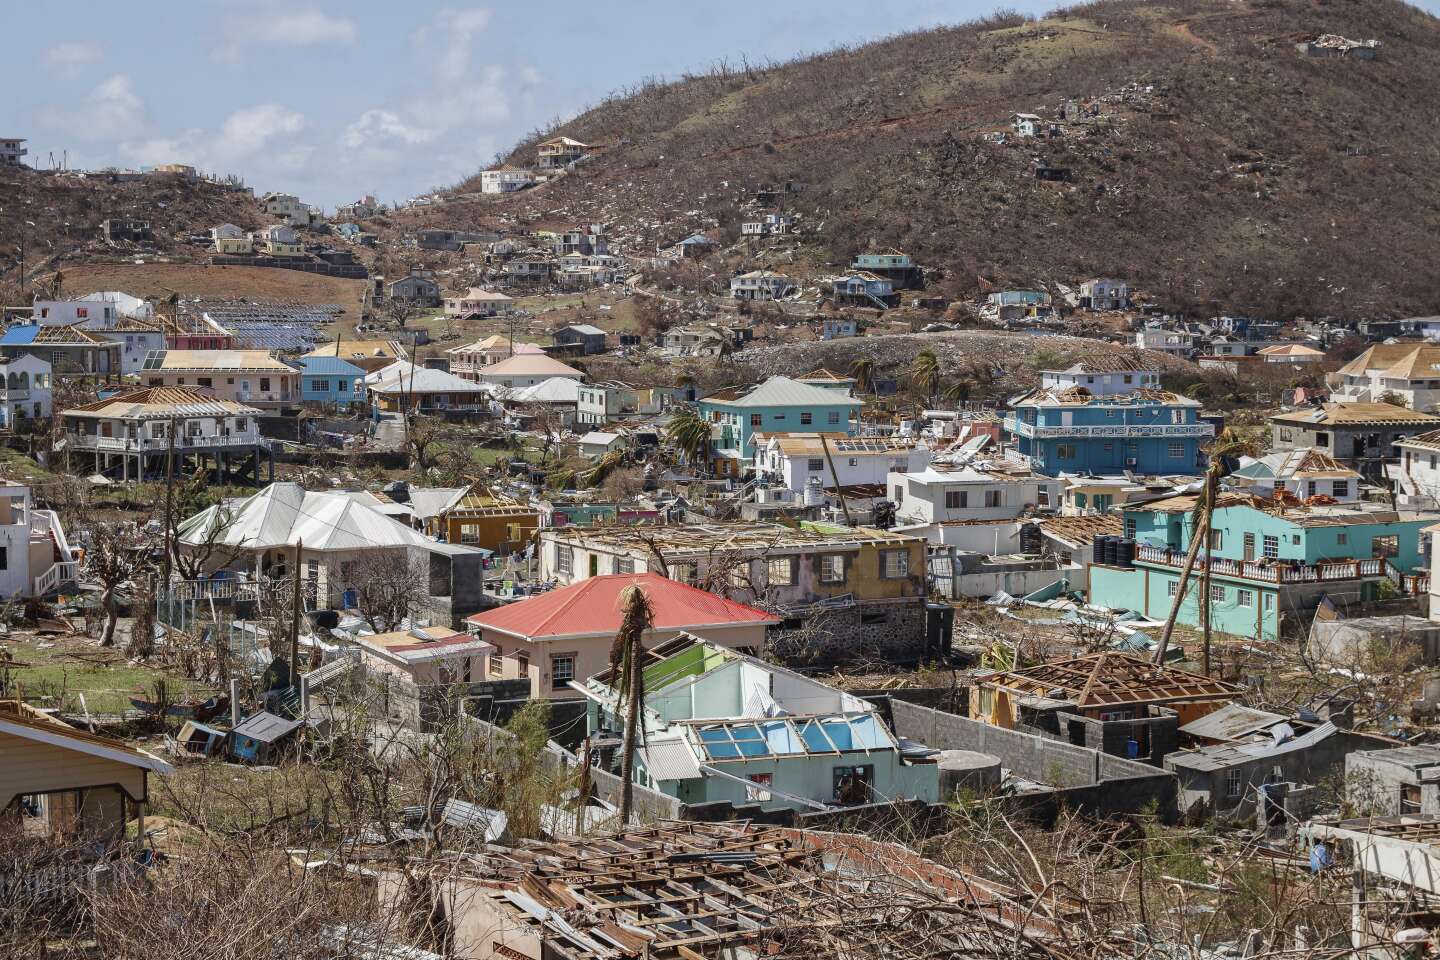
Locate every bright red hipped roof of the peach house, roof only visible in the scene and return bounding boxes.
[465,573,779,639]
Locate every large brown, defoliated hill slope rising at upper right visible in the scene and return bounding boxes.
[432,0,1440,315]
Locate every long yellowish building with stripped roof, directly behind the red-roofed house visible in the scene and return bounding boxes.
[537,522,927,659]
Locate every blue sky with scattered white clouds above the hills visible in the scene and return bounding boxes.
[0,0,1440,207]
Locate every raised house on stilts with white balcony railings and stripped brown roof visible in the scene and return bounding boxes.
[60,387,275,484]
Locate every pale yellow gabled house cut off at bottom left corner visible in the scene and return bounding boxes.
[0,699,173,849]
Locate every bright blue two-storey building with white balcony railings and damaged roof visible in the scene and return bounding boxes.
[1005,357,1215,476]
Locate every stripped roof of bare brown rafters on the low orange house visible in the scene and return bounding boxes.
[975,651,1244,707]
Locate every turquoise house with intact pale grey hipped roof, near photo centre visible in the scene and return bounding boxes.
[698,377,861,476]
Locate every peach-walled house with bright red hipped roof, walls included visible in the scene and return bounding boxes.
[467,573,779,699]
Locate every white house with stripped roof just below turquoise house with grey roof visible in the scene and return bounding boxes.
[752,433,930,494]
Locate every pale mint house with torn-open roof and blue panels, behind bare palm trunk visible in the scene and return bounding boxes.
[572,633,940,810]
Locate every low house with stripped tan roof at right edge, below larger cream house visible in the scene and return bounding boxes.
[1270,402,1440,479]
